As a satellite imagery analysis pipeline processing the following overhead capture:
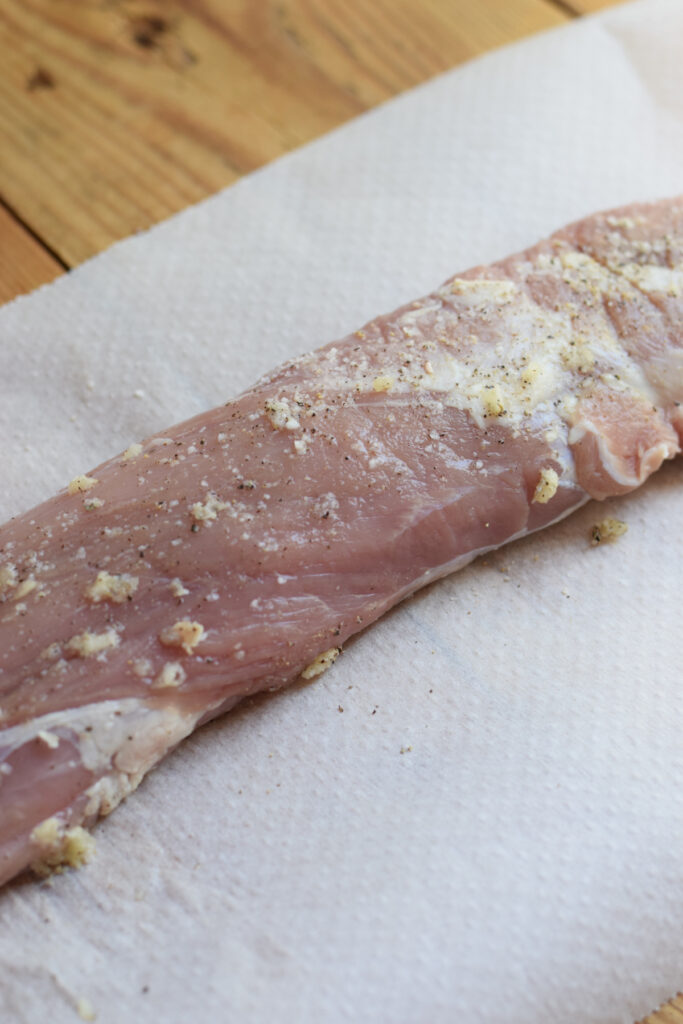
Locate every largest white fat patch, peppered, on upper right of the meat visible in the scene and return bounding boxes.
[313,264,656,460]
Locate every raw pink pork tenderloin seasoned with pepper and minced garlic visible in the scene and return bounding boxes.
[0,199,683,883]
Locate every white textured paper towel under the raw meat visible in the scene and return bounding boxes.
[0,0,683,1024]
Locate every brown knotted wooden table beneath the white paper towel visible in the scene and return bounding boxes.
[0,0,671,1024]
